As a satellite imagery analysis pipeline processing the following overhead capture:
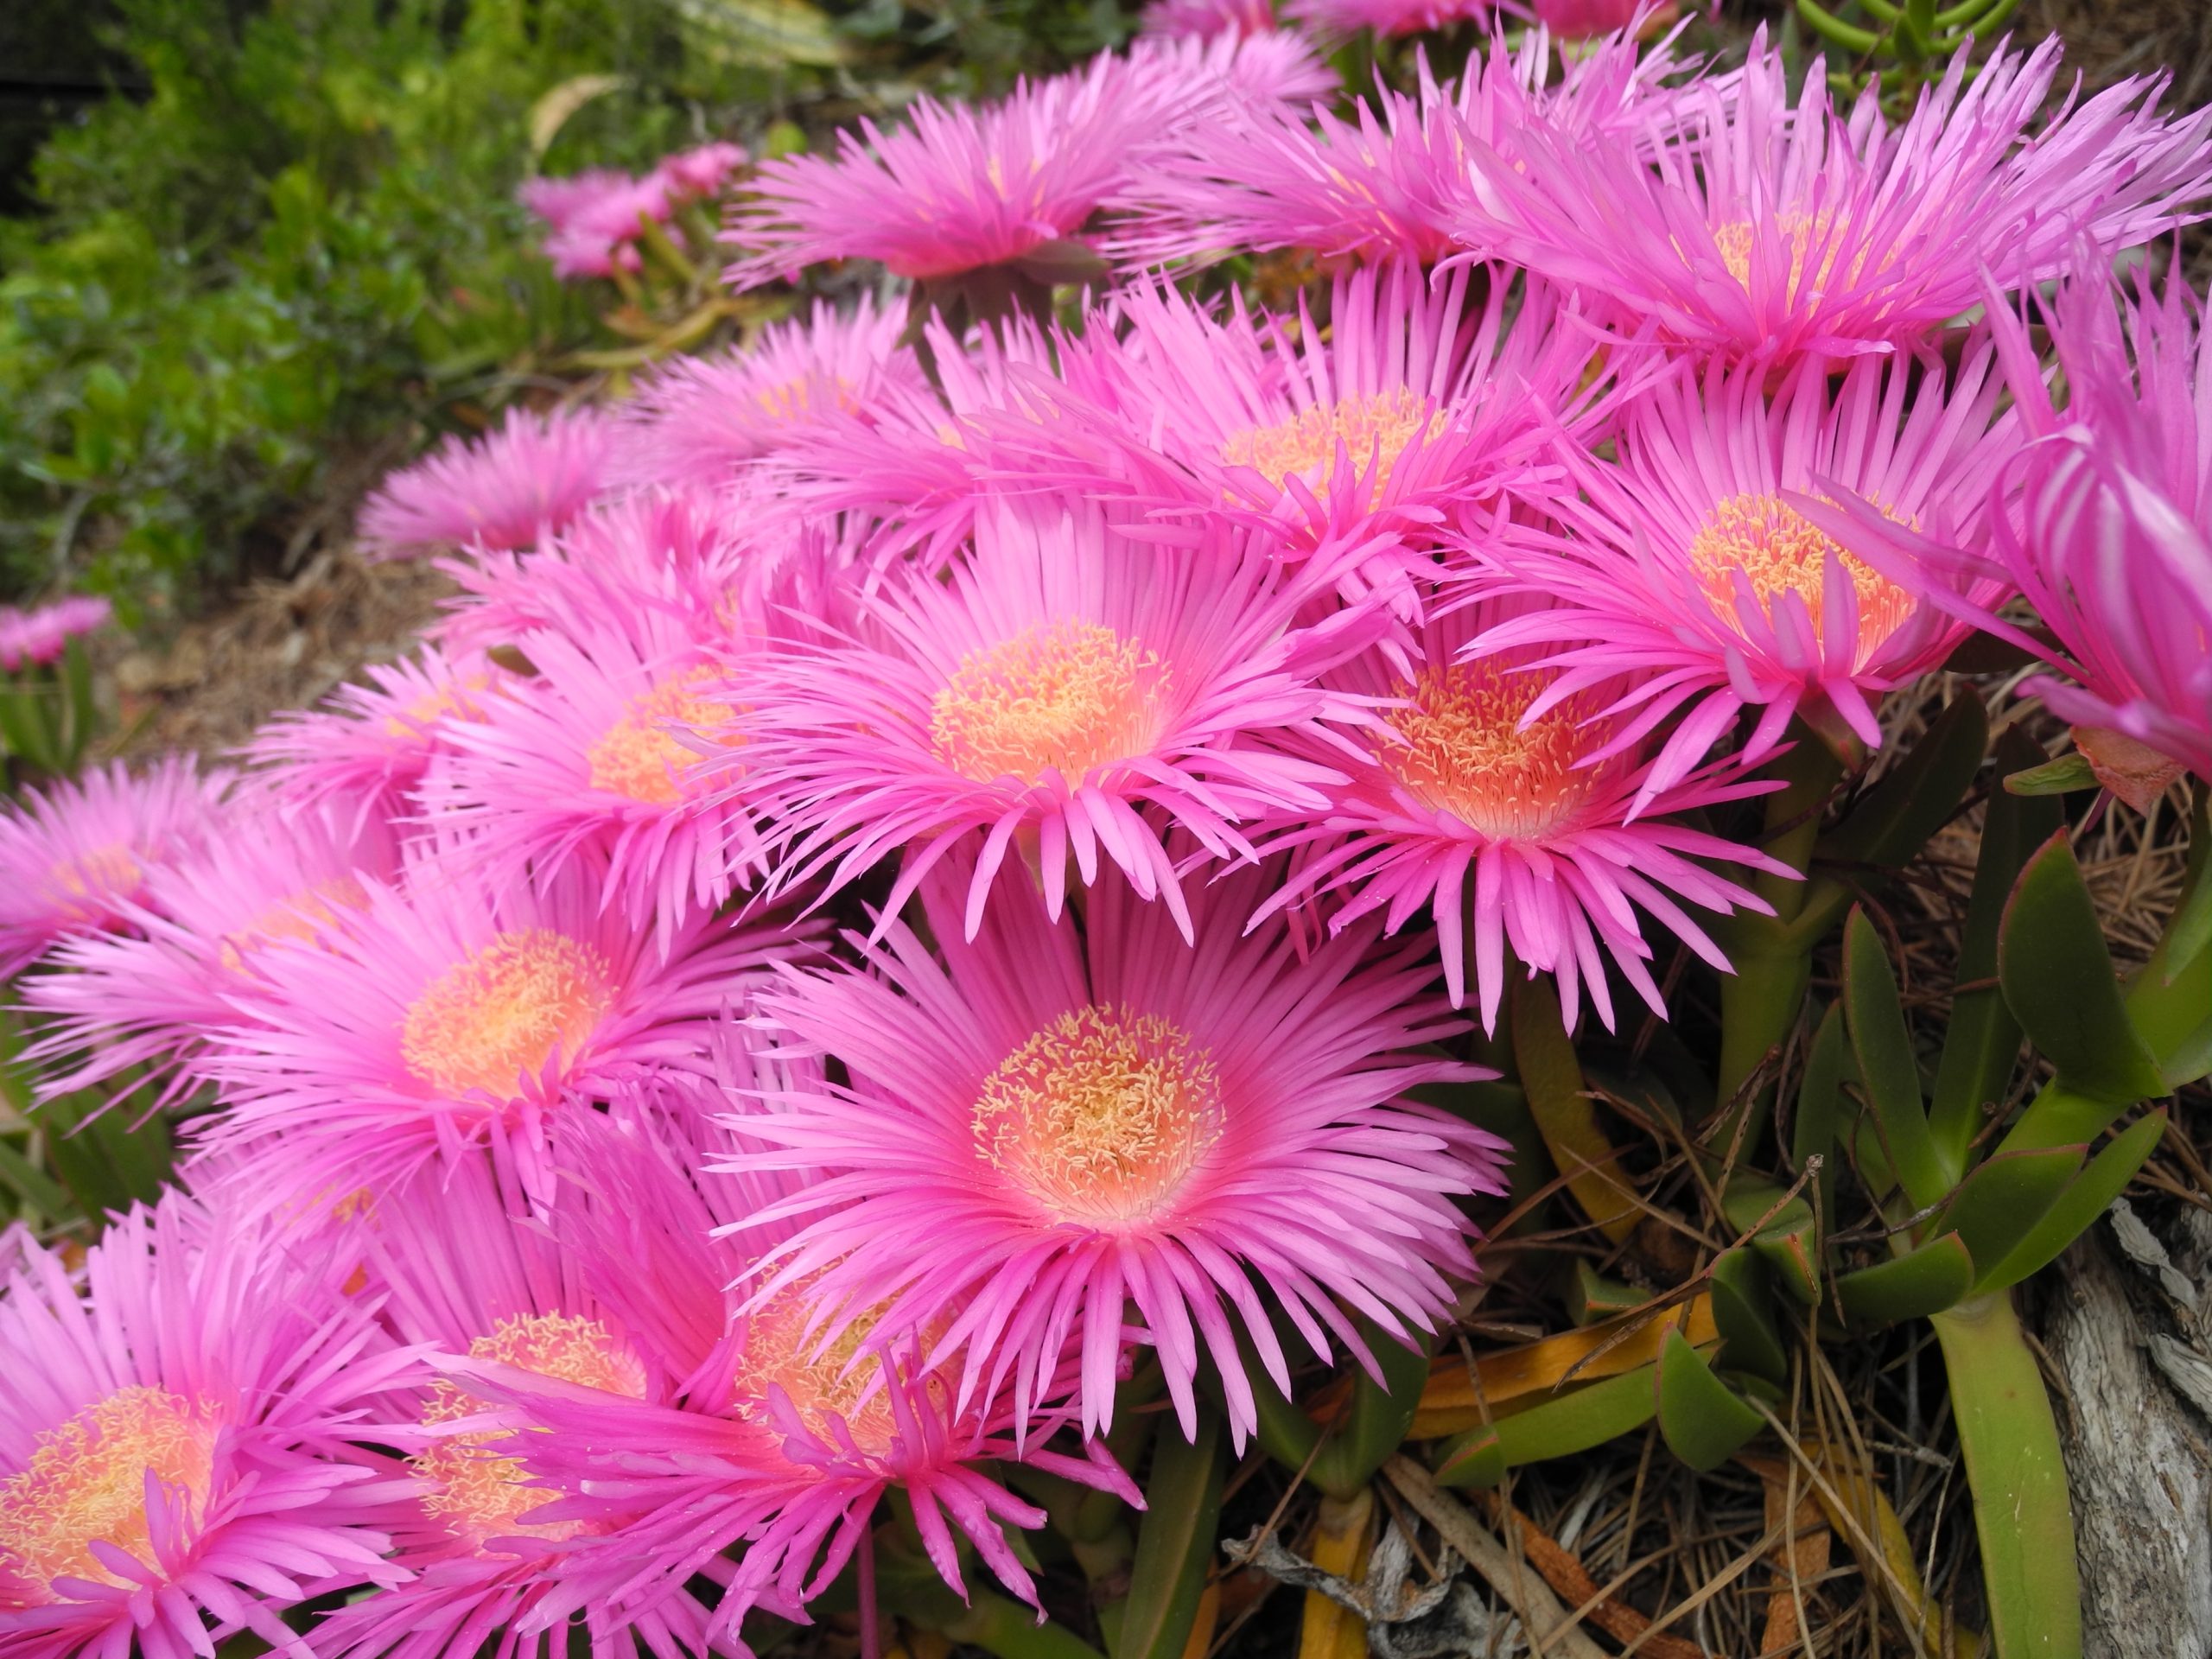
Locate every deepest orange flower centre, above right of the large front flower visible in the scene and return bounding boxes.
[1382,659,1601,841]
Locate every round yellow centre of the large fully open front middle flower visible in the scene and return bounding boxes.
[973,1007,1224,1230]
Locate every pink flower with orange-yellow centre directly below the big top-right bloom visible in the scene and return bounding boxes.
[1466,340,2018,791]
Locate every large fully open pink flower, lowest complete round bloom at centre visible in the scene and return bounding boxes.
[736,865,1502,1445]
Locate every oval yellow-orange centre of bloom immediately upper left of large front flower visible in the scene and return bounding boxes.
[400,927,615,1099]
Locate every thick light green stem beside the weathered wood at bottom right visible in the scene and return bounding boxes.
[1933,1292,2082,1659]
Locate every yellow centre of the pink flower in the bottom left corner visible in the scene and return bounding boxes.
[0,1389,217,1601]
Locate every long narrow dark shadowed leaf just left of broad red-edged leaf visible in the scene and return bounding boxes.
[1929,726,2063,1170]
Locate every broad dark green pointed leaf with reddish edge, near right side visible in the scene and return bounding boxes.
[1998,832,2165,1119]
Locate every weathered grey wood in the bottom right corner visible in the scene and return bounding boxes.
[2044,1212,2212,1659]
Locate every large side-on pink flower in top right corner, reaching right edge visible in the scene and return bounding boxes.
[1460,35,2212,363]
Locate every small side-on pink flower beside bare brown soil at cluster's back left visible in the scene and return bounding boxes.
[359,407,621,557]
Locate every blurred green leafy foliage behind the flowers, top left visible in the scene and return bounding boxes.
[0,0,1126,621]
